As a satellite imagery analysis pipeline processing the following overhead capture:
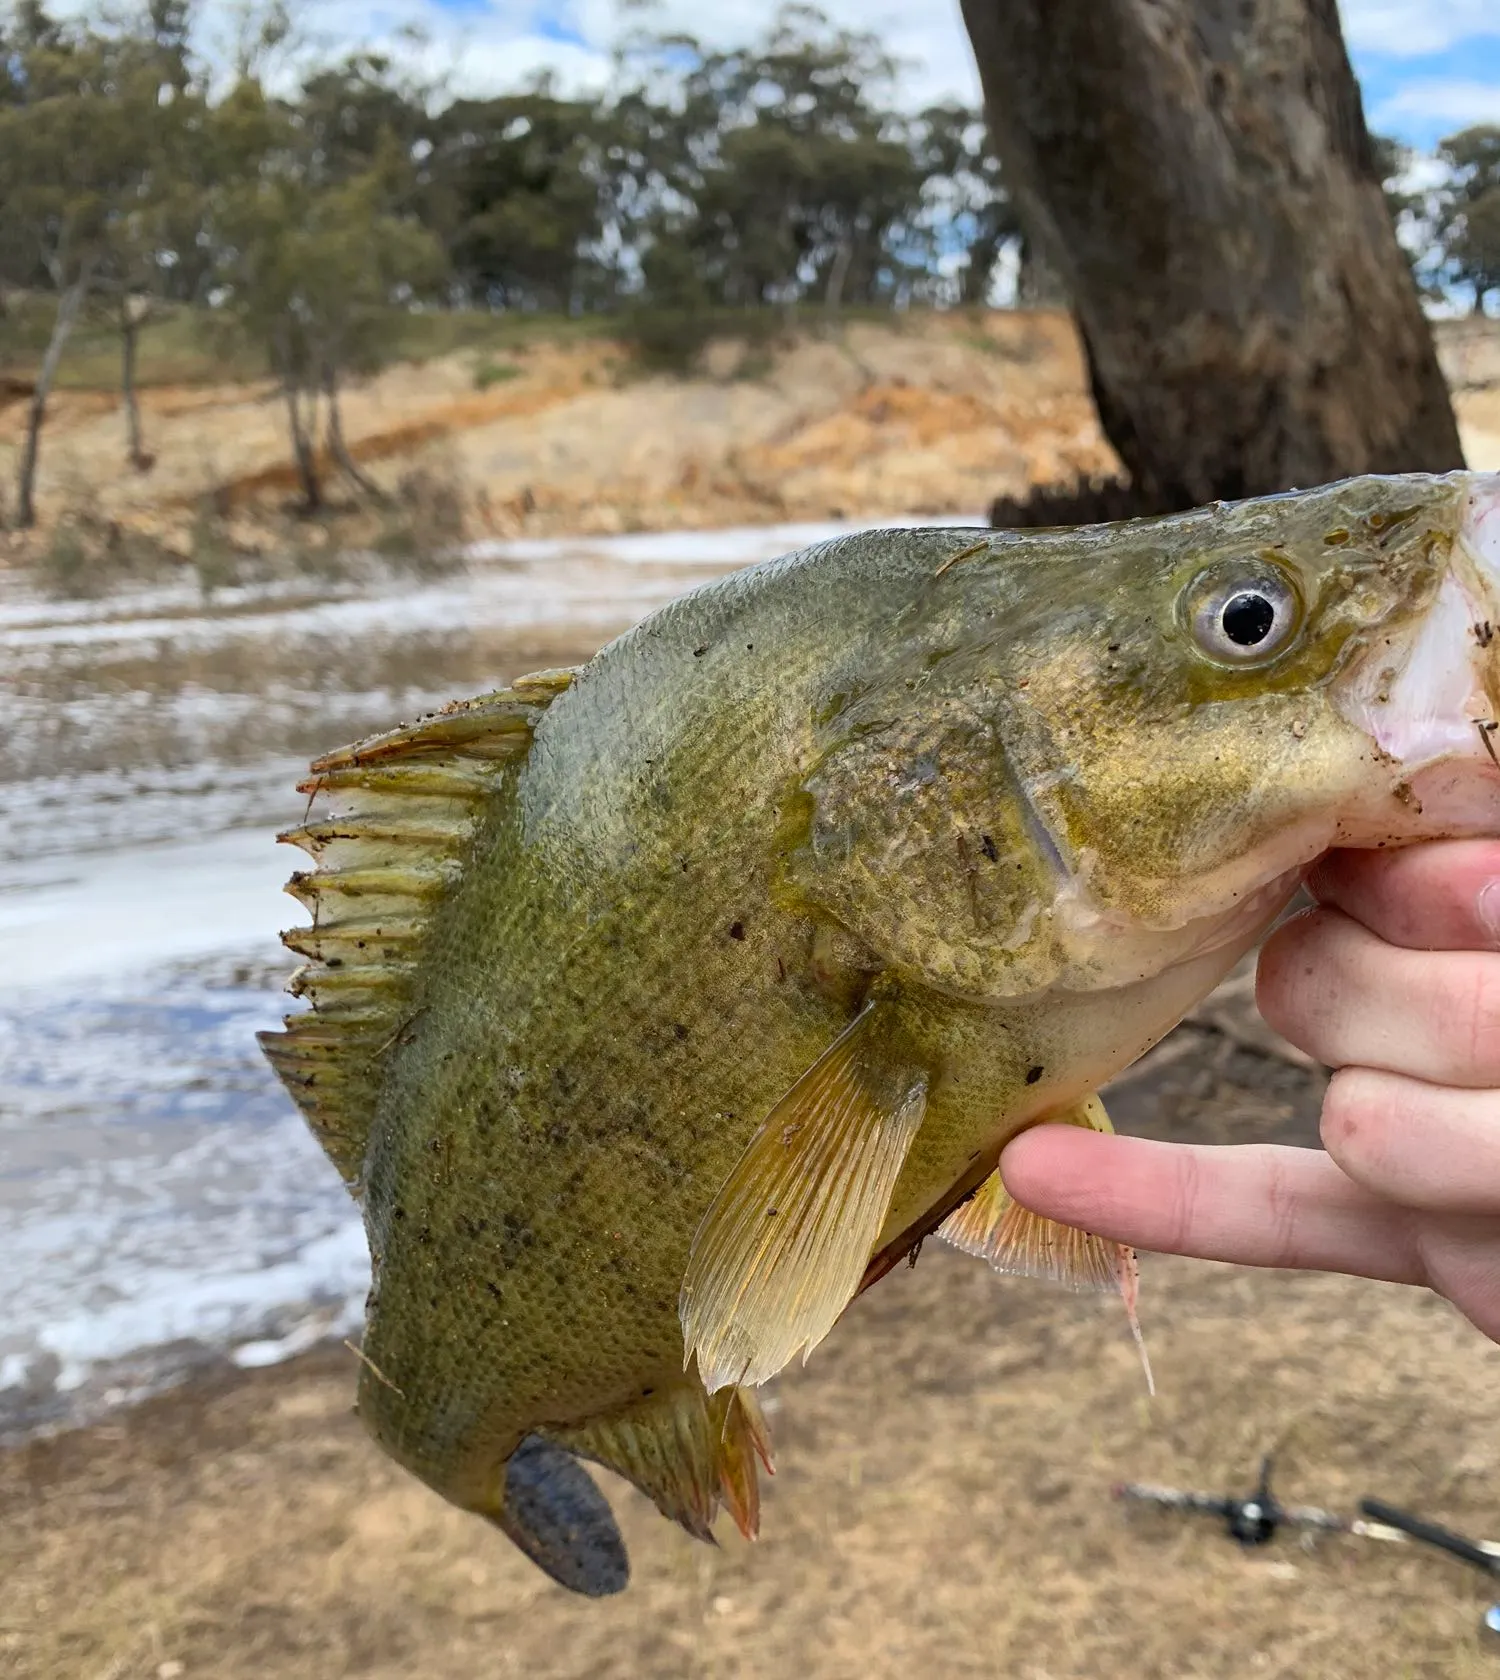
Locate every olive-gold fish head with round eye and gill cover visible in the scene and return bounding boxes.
[782,472,1500,996]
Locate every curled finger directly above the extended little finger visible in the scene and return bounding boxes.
[1322,1067,1500,1215]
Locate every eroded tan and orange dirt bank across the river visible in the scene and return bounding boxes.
[11,311,1500,571]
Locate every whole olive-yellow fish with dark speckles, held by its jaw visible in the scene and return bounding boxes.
[262,472,1500,1596]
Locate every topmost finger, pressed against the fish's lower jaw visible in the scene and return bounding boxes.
[1307,840,1500,951]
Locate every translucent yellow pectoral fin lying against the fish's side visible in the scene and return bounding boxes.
[679,1003,927,1393]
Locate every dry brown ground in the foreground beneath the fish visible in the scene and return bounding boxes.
[0,988,1500,1680]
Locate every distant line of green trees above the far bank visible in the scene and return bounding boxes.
[0,0,1500,526]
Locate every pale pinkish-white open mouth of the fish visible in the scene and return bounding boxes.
[1337,474,1500,780]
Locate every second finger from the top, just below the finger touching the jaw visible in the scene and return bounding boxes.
[1255,909,1500,1085]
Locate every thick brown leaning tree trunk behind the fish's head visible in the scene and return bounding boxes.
[962,0,1463,507]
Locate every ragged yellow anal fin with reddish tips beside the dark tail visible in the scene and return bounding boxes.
[546,1378,771,1541]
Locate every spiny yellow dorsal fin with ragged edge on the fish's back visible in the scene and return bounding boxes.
[260,670,574,1191]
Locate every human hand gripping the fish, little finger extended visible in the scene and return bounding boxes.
[1001,840,1500,1341]
